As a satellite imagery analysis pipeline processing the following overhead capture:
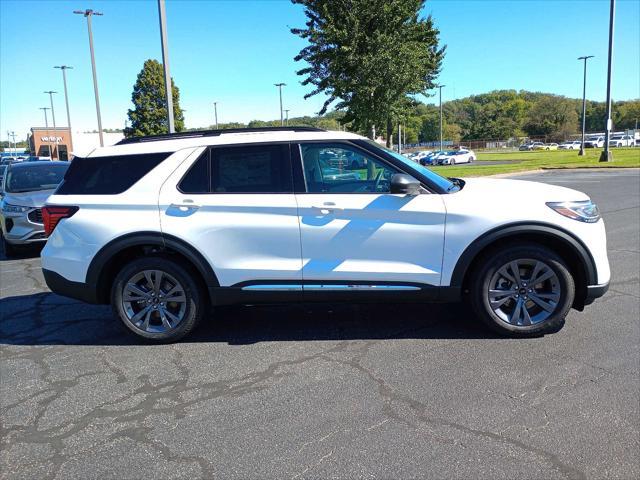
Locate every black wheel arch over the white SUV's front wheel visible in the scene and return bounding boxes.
[450,223,597,310]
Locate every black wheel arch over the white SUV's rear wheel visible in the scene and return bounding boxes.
[86,231,220,303]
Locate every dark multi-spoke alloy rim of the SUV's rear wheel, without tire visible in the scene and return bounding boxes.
[122,270,187,333]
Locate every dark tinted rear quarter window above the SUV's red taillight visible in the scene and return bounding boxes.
[56,153,171,195]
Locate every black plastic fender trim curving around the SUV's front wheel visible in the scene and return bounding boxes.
[451,222,598,288]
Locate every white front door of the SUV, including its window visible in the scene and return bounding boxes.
[293,142,445,291]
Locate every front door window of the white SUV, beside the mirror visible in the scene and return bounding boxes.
[300,143,399,193]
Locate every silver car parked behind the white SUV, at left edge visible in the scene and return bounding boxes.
[0,162,69,257]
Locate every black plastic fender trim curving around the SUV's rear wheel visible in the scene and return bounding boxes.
[85,232,220,302]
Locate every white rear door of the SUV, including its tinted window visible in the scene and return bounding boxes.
[159,143,302,290]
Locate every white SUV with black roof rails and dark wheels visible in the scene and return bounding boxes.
[42,127,610,342]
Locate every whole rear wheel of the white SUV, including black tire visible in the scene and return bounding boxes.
[111,257,206,343]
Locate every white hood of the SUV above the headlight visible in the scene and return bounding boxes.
[454,178,589,203]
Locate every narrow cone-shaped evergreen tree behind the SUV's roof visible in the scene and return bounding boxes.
[124,59,184,137]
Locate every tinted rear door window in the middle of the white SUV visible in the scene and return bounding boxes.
[211,144,293,193]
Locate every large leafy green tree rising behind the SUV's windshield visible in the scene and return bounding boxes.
[291,0,445,145]
